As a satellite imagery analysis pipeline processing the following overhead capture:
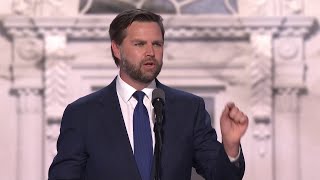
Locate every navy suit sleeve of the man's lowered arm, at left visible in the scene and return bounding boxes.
[48,105,88,180]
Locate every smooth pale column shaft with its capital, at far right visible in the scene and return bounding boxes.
[274,88,301,180]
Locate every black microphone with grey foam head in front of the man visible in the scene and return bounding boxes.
[152,88,165,124]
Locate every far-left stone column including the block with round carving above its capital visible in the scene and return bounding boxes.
[12,37,44,180]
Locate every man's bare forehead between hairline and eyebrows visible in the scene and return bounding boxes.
[126,21,162,40]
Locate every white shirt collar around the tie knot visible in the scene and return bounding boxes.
[116,75,156,102]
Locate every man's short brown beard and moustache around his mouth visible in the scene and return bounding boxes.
[120,56,163,83]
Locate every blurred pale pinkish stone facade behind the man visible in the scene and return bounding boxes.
[0,0,320,180]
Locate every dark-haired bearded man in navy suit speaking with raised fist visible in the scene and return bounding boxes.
[49,9,248,180]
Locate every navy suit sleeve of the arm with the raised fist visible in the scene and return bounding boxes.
[193,99,245,180]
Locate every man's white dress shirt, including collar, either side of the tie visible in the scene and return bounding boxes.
[116,75,156,152]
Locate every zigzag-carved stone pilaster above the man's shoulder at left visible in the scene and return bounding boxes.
[44,35,73,119]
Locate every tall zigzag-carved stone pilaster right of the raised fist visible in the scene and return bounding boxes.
[250,33,273,180]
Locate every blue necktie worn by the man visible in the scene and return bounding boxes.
[133,91,153,180]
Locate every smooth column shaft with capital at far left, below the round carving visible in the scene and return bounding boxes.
[12,87,43,180]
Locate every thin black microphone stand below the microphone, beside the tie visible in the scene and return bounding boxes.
[153,113,163,180]
